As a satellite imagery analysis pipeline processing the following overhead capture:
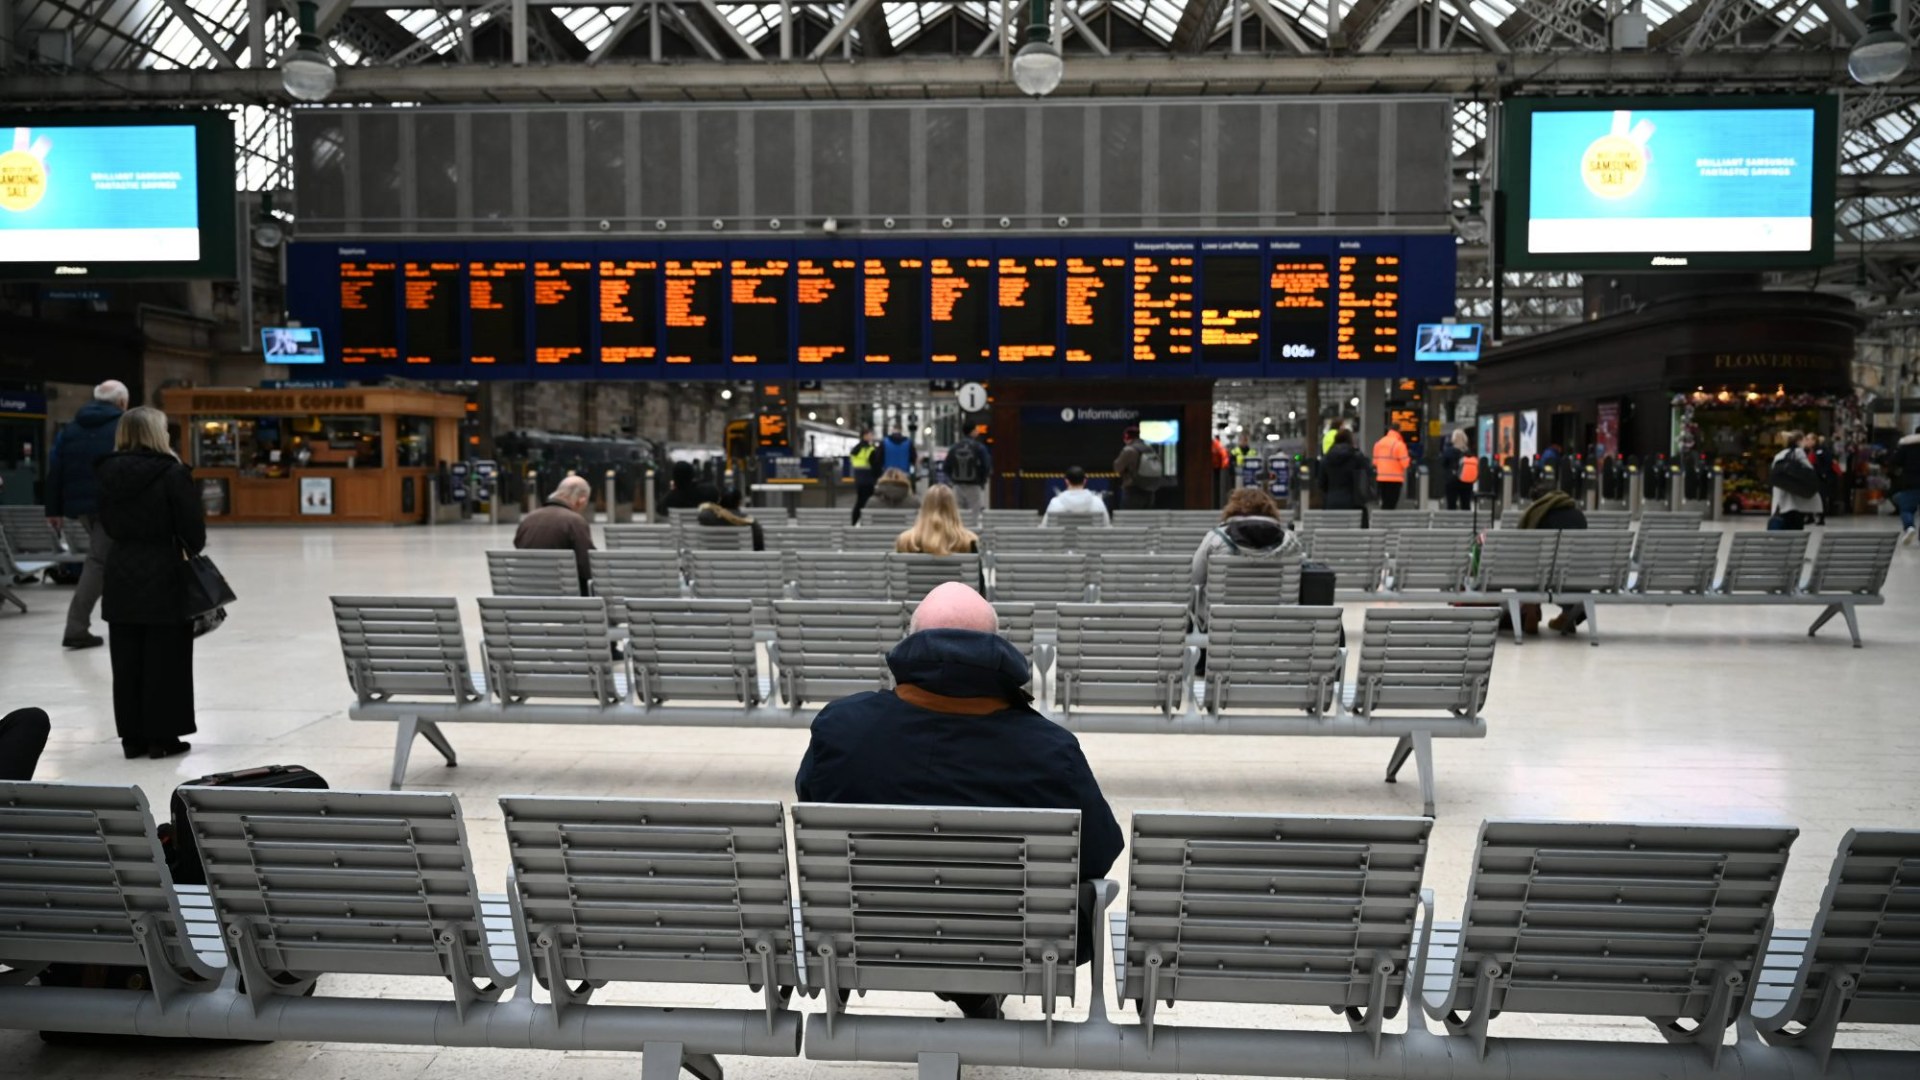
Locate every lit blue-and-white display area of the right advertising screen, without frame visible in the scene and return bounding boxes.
[1524,108,1816,256]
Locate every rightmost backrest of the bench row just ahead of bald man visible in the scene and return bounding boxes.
[1354,607,1500,717]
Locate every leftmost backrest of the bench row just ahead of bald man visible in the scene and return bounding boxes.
[332,596,480,701]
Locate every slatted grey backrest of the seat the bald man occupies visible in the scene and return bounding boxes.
[793,803,1092,1011]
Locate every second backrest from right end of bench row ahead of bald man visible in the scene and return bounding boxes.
[1206,605,1346,717]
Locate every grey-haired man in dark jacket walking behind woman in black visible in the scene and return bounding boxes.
[46,379,127,650]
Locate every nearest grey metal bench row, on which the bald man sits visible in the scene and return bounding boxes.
[0,782,1920,1080]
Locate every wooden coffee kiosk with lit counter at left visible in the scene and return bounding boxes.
[161,388,467,525]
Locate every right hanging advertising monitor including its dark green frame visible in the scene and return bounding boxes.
[1500,94,1839,271]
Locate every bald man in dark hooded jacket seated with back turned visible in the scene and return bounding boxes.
[793,582,1125,1017]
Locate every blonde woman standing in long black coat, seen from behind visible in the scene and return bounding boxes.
[94,405,207,757]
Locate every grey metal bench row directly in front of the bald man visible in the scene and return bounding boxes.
[332,596,1498,815]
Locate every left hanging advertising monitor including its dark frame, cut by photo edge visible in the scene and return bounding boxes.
[0,111,236,281]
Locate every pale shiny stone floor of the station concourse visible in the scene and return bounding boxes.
[0,519,1920,1080]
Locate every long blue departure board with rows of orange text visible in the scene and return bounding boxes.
[288,234,1455,379]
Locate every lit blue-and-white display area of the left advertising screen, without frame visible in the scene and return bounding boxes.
[0,123,202,263]
